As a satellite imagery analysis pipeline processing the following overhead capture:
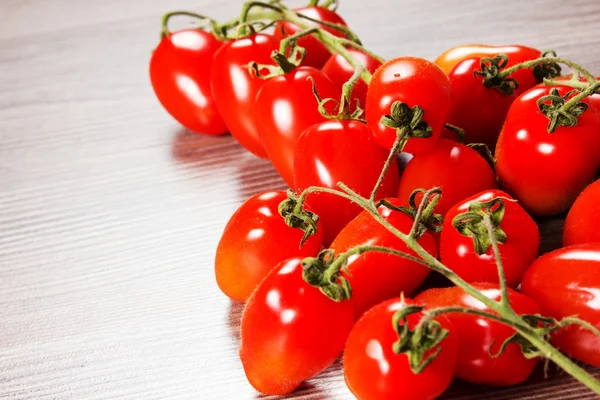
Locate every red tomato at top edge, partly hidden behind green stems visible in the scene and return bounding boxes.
[273,6,347,68]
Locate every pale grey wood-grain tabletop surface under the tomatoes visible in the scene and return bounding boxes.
[0,0,600,400]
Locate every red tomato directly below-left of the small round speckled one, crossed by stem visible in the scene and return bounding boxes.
[294,120,400,246]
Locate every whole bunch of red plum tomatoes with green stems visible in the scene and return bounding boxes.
[150,1,600,399]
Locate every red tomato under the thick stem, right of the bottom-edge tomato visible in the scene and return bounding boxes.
[415,283,539,386]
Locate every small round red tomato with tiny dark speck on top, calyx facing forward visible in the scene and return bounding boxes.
[365,57,450,154]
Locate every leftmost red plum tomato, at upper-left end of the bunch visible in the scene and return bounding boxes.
[150,29,227,135]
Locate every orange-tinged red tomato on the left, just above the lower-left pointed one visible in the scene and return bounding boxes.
[215,190,323,302]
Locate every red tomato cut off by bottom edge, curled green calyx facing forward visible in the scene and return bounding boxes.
[344,298,458,400]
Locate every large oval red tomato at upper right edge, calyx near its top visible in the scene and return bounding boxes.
[496,86,600,216]
